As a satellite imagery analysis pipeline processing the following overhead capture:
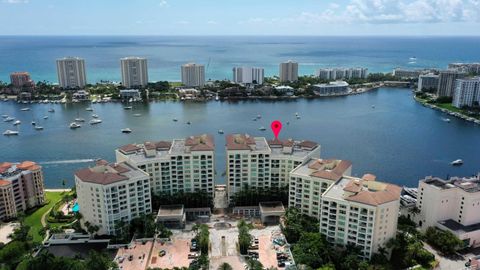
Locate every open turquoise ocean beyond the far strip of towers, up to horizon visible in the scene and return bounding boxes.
[0,36,480,83]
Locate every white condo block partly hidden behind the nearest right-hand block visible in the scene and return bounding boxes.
[288,159,352,220]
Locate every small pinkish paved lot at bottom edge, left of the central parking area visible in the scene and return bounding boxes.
[115,241,153,270]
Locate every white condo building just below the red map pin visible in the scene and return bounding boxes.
[226,134,320,197]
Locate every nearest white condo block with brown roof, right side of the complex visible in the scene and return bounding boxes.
[320,174,401,259]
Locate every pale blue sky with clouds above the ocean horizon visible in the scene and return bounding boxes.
[0,0,480,36]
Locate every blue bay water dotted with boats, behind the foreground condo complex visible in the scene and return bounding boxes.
[0,88,480,188]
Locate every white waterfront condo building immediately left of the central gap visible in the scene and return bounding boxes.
[115,135,215,194]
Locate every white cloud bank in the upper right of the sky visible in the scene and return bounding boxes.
[239,0,480,25]
